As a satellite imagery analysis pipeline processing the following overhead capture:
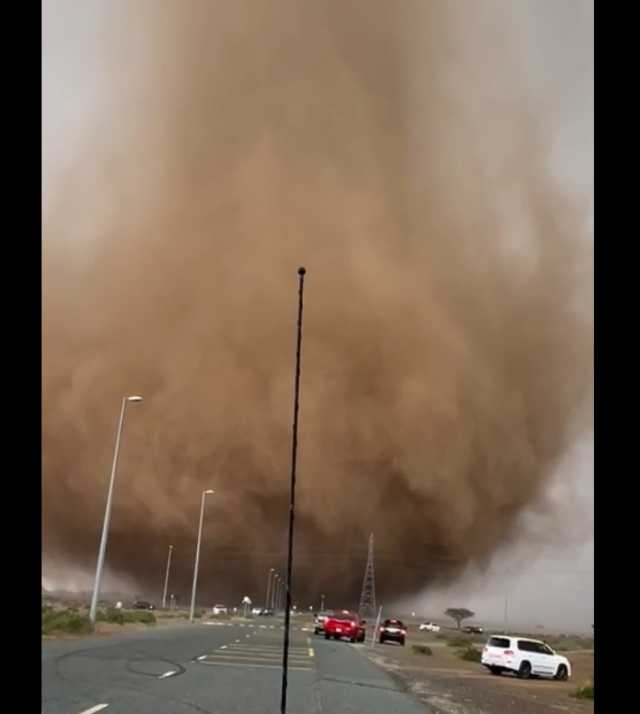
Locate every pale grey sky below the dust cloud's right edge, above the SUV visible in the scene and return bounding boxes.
[392,433,594,633]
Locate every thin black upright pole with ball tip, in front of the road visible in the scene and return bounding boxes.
[280,268,306,714]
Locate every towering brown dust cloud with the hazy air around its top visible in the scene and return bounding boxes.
[43,0,592,602]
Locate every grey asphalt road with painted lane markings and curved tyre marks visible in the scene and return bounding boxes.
[42,621,429,714]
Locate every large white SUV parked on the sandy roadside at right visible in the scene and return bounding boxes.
[481,635,571,681]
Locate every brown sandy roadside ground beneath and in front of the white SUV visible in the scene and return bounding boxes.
[363,635,594,714]
